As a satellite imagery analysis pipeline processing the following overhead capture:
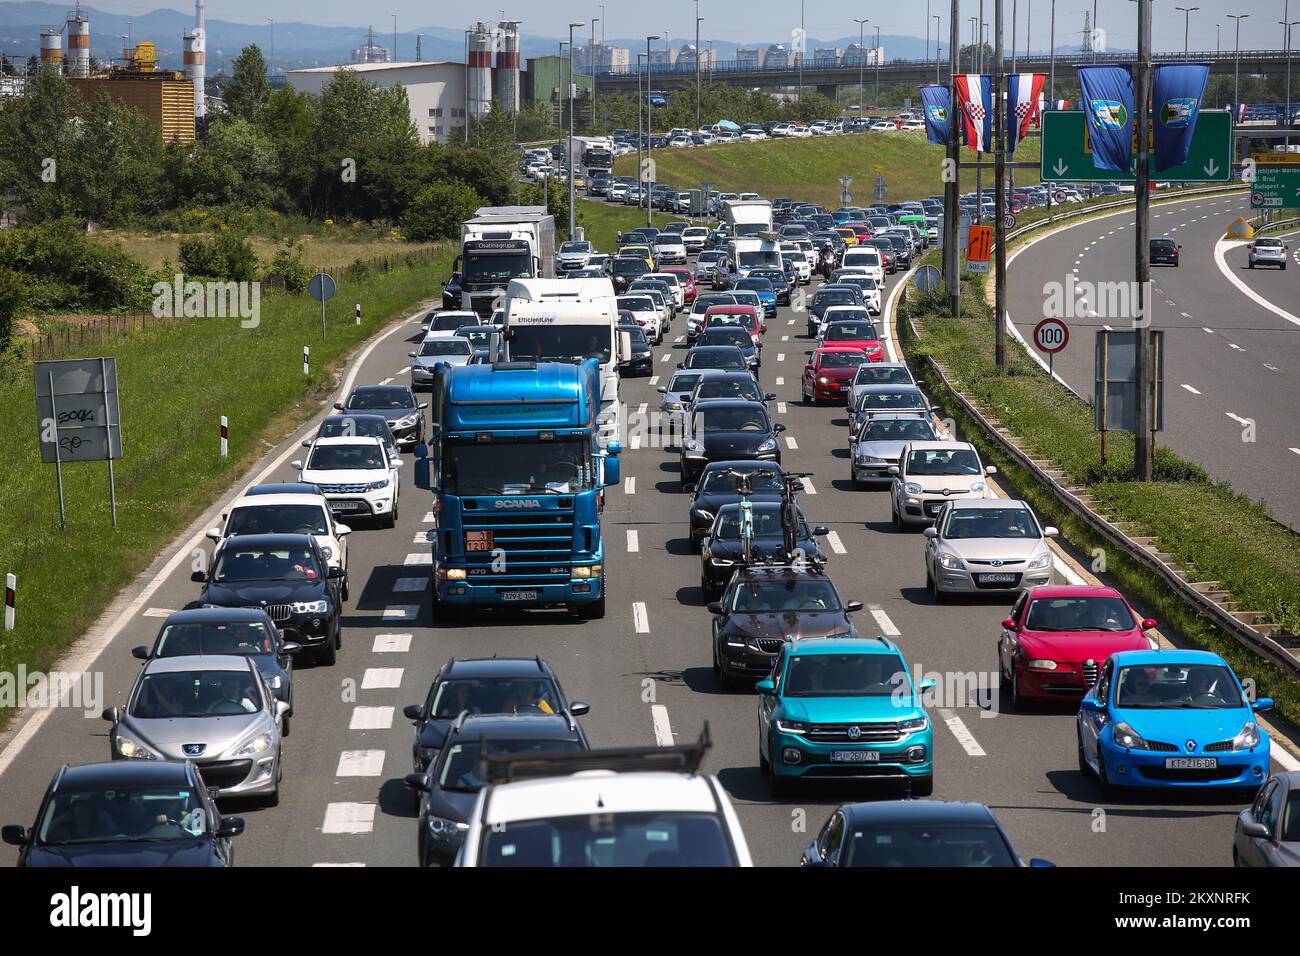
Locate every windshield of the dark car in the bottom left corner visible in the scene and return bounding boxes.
[34,786,213,847]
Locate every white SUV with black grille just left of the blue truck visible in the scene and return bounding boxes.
[293,437,402,528]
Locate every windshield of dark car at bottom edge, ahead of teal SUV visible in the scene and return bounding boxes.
[840,825,1015,868]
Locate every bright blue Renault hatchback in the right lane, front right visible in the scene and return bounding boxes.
[1078,650,1273,792]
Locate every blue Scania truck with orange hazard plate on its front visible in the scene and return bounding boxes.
[415,359,620,618]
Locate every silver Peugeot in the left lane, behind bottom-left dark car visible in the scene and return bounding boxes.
[104,654,289,806]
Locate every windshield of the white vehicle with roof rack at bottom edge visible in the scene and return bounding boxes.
[478,810,736,868]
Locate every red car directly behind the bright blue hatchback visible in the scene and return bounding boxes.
[997,584,1156,708]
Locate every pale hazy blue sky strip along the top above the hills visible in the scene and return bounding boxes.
[76,0,1300,52]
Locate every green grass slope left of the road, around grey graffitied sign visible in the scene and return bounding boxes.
[0,239,452,726]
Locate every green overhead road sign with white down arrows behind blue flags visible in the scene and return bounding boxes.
[1039,109,1232,182]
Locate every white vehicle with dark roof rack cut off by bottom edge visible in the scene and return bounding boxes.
[456,740,754,868]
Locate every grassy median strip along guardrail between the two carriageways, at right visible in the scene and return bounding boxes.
[897,254,1300,723]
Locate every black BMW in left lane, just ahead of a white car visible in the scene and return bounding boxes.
[189,535,343,665]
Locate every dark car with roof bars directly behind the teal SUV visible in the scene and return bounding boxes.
[709,562,862,689]
